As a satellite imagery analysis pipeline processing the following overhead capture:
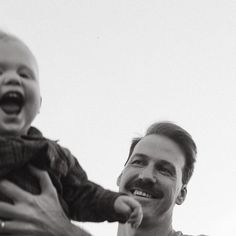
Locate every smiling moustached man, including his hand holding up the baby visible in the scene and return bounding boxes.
[0,122,206,236]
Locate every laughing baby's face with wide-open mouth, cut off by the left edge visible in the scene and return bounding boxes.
[0,40,41,136]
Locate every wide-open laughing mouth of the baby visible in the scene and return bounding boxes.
[0,91,24,115]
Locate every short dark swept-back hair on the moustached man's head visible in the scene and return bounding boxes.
[125,121,197,184]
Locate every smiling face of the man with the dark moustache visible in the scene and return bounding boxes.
[117,135,186,221]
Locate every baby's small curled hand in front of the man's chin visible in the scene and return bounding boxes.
[114,195,143,228]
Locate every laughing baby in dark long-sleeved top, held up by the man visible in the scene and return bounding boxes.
[0,31,142,230]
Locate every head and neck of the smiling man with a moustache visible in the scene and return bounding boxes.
[117,122,206,236]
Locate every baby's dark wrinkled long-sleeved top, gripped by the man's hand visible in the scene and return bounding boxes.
[0,127,127,223]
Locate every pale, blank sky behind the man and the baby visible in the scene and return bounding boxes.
[0,0,236,236]
